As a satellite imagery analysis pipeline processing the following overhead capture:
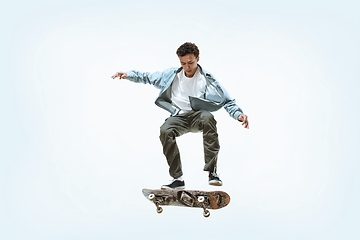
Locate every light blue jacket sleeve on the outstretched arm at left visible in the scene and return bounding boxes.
[126,69,173,89]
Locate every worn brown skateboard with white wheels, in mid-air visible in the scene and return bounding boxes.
[142,188,230,217]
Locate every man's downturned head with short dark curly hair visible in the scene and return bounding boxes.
[176,42,199,78]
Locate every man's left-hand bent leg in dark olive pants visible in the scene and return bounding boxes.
[160,114,189,178]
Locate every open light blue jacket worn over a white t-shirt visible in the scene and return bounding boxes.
[126,65,243,120]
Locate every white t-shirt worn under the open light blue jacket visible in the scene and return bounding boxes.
[171,68,206,113]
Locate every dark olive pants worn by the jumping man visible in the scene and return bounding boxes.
[160,110,220,178]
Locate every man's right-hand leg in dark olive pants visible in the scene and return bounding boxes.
[191,111,220,172]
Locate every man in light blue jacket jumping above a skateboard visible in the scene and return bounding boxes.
[112,42,249,189]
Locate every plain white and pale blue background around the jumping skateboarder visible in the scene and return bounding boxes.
[0,0,360,240]
